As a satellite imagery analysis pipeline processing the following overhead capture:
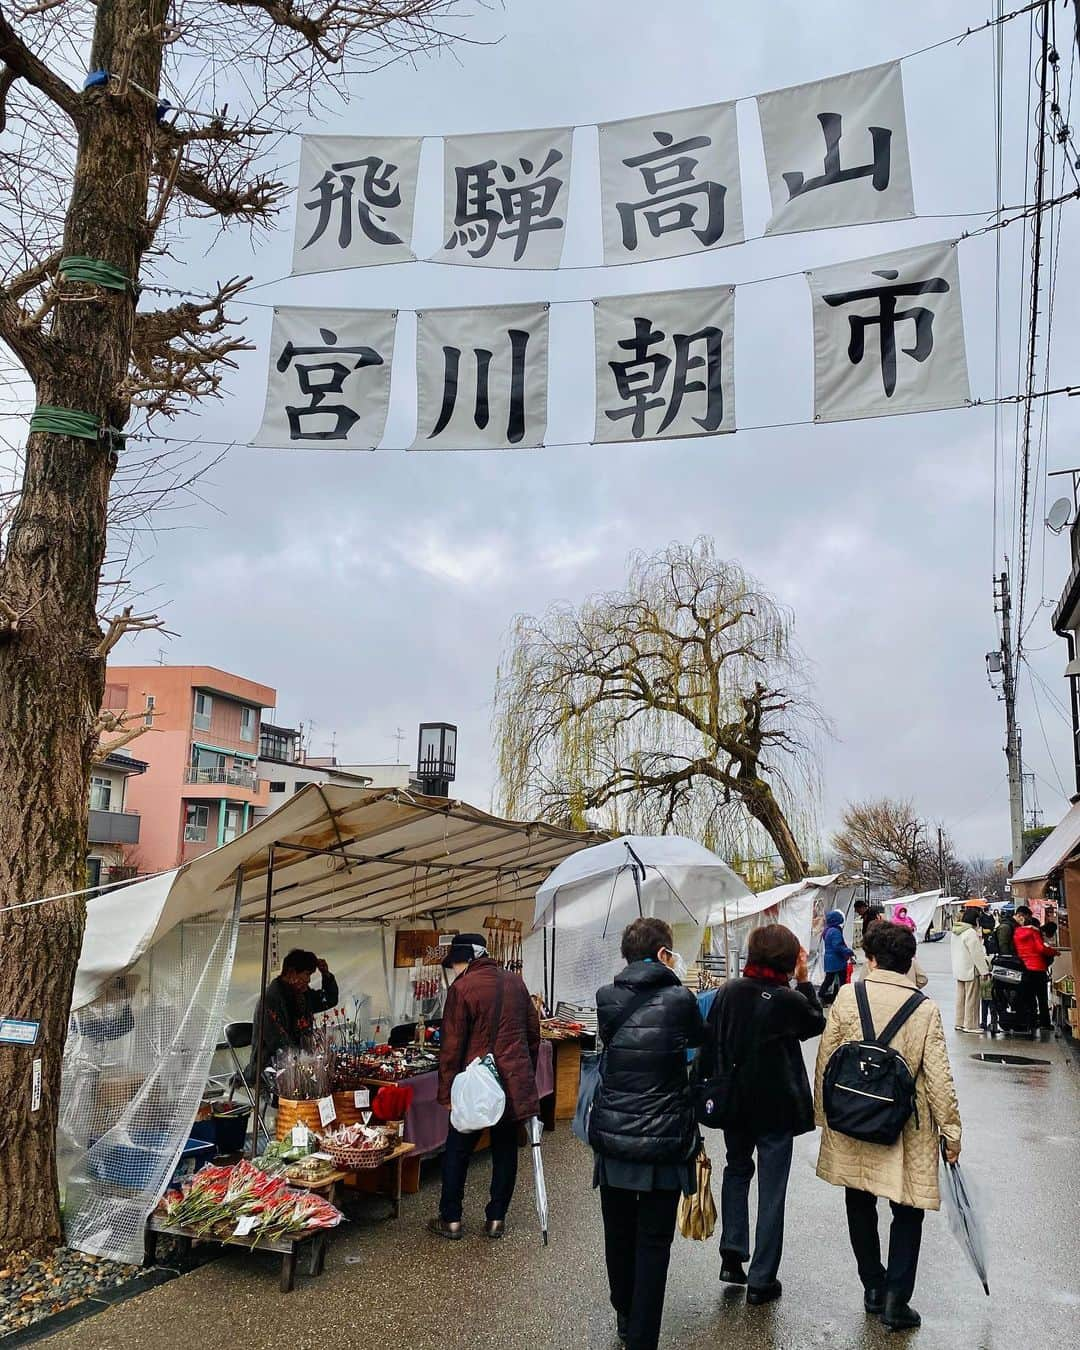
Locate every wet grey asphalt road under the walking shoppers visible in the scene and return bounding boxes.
[47,941,1080,1350]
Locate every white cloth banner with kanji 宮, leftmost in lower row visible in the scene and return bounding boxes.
[251,305,397,450]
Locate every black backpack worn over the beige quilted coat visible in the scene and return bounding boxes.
[822,980,925,1143]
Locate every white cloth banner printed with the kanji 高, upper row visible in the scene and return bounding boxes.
[599,103,744,266]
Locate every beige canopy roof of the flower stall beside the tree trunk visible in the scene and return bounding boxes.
[74,783,608,1007]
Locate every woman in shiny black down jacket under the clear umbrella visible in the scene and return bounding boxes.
[589,918,705,1350]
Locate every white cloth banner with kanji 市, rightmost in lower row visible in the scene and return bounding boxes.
[806,240,971,421]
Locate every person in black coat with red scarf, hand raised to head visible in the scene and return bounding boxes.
[695,923,825,1304]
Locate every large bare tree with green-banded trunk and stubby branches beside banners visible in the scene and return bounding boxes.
[0,0,459,1251]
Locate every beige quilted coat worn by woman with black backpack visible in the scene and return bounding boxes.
[814,971,960,1210]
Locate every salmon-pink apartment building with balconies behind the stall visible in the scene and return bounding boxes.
[105,666,277,872]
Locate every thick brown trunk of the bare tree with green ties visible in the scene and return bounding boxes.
[0,0,167,1251]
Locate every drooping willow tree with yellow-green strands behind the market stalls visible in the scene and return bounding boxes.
[494,539,822,880]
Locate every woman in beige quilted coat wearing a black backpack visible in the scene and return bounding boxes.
[814,923,960,1331]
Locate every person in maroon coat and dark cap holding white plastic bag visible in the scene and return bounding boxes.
[428,933,540,1239]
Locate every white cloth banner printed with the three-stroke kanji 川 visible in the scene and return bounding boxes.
[413,304,548,450]
